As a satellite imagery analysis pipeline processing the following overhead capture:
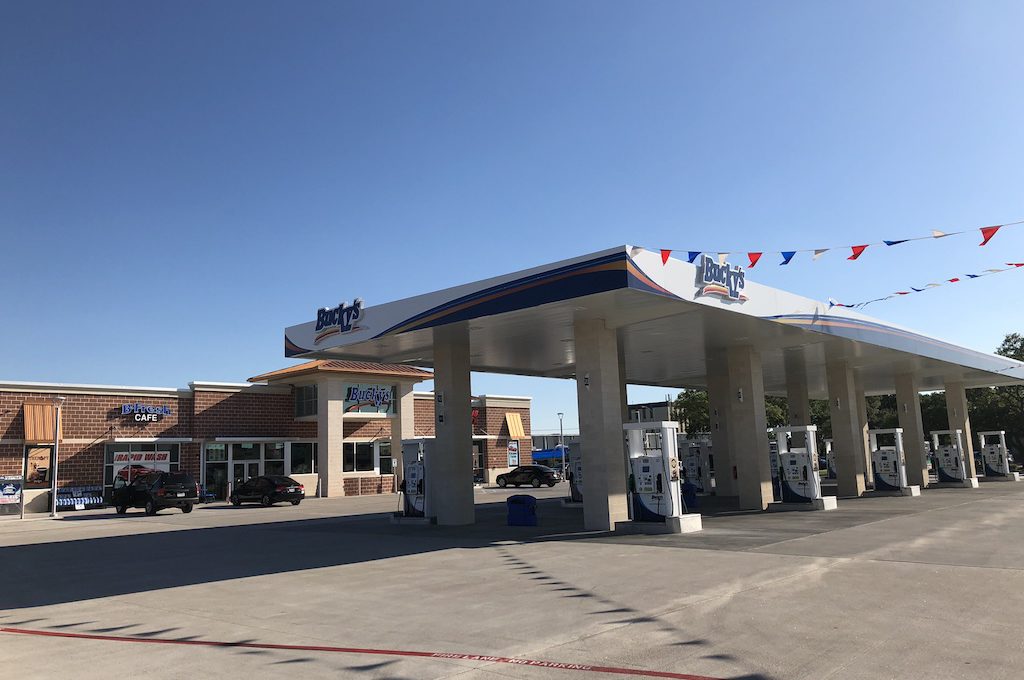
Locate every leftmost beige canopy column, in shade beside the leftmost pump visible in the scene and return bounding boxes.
[427,324,476,525]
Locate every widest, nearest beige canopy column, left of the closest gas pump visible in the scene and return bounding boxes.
[573,318,629,532]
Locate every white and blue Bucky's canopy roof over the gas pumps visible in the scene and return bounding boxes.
[285,246,1024,398]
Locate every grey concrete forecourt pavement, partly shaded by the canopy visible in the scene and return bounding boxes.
[0,483,1024,680]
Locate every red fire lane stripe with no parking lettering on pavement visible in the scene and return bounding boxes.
[0,627,722,680]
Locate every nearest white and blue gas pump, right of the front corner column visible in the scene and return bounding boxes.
[623,421,701,534]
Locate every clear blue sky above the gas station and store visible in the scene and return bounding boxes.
[0,0,1024,430]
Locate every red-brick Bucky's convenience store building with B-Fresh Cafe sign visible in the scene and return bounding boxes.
[0,360,530,511]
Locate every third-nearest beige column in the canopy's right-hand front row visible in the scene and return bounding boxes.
[825,359,865,496]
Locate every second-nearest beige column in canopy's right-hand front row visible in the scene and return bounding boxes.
[726,347,772,510]
